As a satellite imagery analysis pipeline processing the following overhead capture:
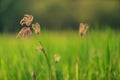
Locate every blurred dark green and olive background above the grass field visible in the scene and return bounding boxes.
[0,0,120,32]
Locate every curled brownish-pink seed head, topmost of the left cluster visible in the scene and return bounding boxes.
[20,14,33,26]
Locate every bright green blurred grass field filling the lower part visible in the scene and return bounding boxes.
[0,30,120,80]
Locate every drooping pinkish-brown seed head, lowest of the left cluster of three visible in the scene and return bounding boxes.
[17,27,32,38]
